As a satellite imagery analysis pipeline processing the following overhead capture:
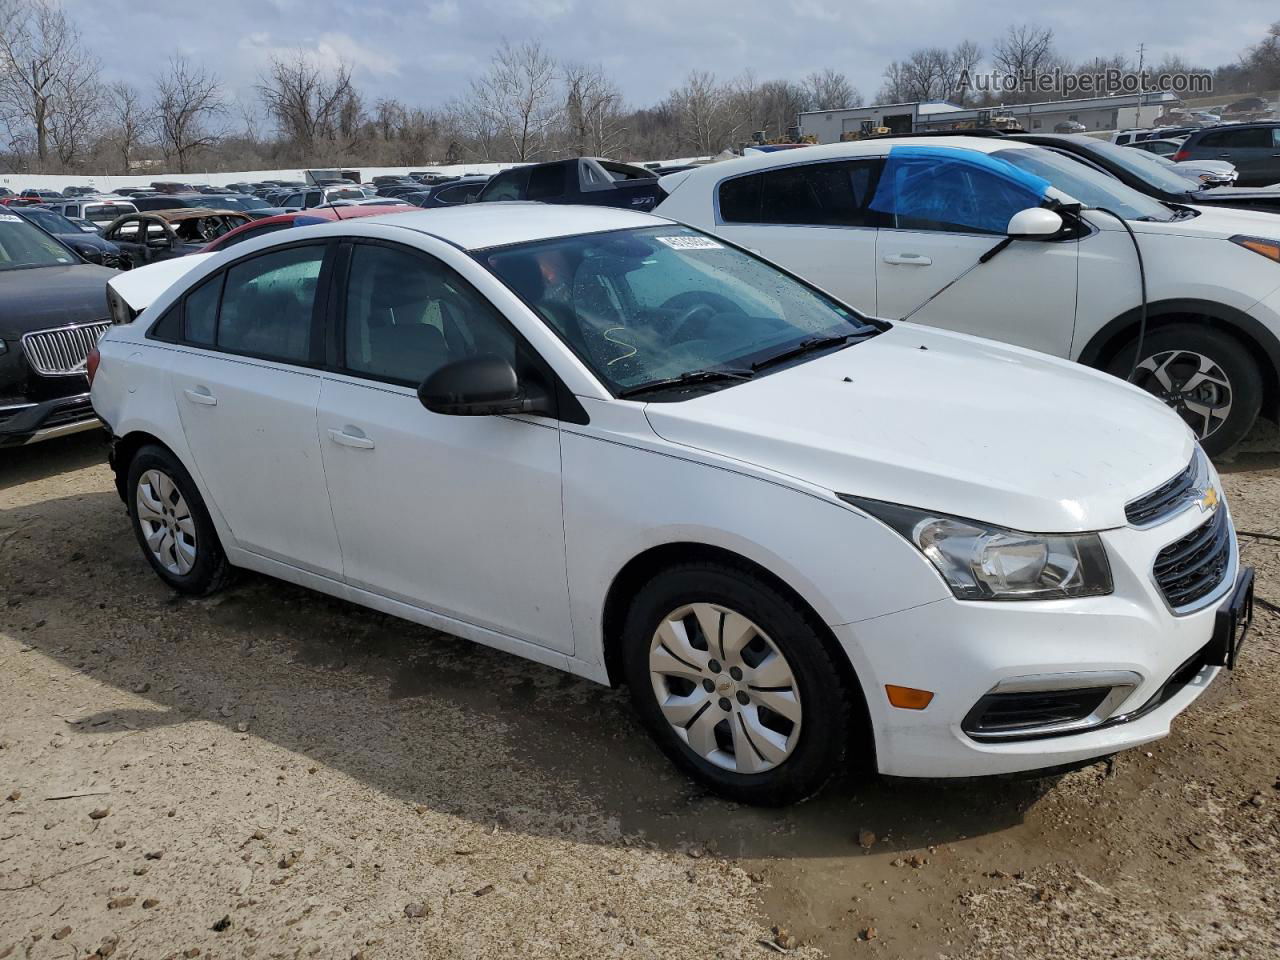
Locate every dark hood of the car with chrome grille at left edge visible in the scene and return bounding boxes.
[0,264,118,339]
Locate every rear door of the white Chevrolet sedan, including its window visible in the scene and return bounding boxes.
[170,243,342,580]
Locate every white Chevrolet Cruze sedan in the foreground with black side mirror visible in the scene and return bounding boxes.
[90,204,1252,803]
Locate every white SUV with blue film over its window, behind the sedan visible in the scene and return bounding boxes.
[655,137,1280,454]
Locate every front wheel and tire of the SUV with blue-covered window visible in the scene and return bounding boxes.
[1107,324,1262,457]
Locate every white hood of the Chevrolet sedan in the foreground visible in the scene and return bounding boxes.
[645,324,1194,532]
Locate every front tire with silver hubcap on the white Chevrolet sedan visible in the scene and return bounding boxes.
[622,562,870,806]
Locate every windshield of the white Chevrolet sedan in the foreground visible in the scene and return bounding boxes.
[476,225,879,396]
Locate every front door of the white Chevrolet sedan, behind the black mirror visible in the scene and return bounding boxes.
[319,242,573,653]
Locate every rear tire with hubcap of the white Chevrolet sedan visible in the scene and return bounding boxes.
[125,445,234,596]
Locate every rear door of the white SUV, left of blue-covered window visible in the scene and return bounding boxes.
[713,157,882,316]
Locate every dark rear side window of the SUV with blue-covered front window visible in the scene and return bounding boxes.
[719,160,879,227]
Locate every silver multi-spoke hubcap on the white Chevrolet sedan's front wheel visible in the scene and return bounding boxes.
[649,603,801,773]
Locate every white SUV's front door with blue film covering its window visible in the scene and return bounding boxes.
[873,155,1079,357]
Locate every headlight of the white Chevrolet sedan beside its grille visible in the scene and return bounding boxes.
[840,494,1111,600]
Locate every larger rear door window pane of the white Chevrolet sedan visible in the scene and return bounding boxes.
[218,244,325,364]
